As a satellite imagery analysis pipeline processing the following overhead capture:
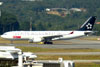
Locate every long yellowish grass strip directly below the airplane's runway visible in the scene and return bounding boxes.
[17,46,100,53]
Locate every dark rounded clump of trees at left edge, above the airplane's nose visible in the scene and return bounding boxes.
[0,12,19,34]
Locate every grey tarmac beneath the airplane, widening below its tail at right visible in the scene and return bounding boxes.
[11,39,100,49]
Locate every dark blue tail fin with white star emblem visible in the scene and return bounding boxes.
[79,16,96,31]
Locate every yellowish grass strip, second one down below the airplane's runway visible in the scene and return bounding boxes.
[37,55,100,60]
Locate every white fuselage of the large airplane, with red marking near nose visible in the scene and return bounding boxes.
[1,31,86,42]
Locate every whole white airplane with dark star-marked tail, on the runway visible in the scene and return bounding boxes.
[1,16,96,44]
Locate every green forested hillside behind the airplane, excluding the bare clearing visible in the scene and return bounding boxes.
[0,0,100,35]
